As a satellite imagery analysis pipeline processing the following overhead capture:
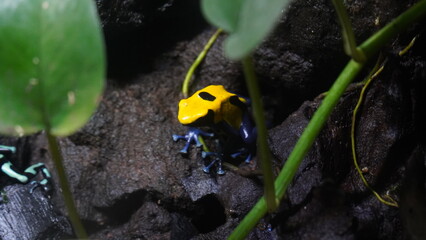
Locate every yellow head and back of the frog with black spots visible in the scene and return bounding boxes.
[178,85,246,129]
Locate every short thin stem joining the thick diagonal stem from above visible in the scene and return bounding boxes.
[332,0,366,62]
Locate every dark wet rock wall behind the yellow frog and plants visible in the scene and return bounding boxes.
[0,0,426,240]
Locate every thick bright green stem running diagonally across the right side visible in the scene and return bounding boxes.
[229,0,426,239]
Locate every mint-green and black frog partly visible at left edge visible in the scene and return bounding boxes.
[0,145,52,193]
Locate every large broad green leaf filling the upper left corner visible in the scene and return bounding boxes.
[0,0,105,136]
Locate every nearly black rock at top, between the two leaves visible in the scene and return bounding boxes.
[96,0,210,80]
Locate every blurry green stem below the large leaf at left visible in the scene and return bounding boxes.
[46,131,87,239]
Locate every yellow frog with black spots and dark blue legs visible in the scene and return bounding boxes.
[173,85,257,174]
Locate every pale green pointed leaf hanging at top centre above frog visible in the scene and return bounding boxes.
[202,0,290,60]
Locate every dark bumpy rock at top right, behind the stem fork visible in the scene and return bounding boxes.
[254,0,412,125]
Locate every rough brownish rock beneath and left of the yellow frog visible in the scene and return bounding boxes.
[31,25,262,239]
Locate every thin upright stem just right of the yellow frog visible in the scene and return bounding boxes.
[242,56,277,212]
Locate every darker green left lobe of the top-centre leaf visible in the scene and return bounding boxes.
[201,0,244,33]
